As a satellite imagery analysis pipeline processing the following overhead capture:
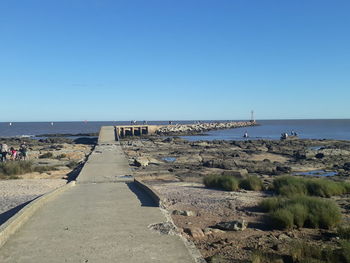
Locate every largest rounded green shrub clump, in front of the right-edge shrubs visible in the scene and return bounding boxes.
[260,196,341,229]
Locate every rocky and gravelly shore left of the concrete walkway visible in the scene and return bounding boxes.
[0,137,94,224]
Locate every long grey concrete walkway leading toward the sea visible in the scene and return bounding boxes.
[0,127,194,263]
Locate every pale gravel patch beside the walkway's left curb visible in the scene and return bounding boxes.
[0,179,67,217]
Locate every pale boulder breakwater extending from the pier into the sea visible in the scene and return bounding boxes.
[156,121,258,135]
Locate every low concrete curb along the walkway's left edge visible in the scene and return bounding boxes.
[0,181,75,251]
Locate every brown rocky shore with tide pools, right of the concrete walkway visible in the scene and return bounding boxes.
[122,137,350,262]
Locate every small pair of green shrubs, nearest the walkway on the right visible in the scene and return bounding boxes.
[203,175,263,191]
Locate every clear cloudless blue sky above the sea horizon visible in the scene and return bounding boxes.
[0,0,350,121]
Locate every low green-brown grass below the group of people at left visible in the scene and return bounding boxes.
[0,161,55,179]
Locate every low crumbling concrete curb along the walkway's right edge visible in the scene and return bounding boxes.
[134,178,206,263]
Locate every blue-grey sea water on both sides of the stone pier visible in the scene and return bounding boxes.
[0,119,350,141]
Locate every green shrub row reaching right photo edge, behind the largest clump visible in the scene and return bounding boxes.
[273,176,350,197]
